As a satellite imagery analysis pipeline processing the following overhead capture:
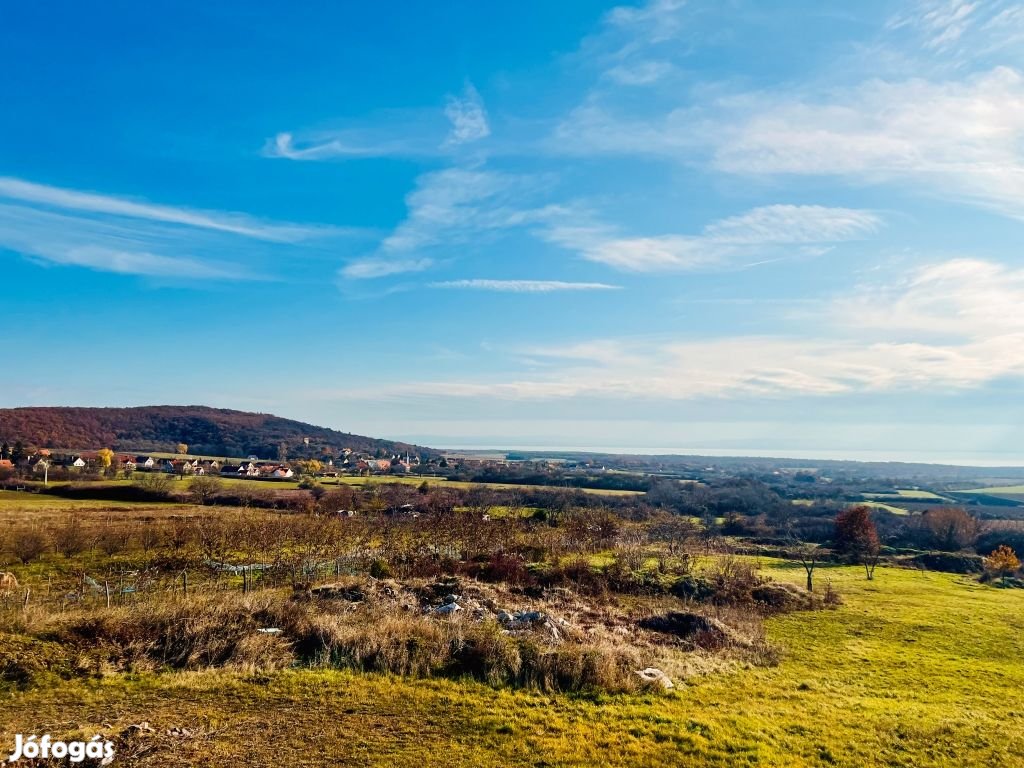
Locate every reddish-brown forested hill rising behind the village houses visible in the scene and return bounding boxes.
[0,406,434,458]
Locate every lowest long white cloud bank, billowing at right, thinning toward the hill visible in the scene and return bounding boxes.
[342,258,1024,400]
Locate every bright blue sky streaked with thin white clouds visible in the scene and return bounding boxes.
[0,0,1024,464]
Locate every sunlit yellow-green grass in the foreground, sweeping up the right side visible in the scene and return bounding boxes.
[0,561,1024,768]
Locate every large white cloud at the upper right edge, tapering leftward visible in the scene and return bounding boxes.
[551,63,1024,218]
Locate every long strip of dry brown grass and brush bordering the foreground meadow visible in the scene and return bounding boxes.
[46,593,649,691]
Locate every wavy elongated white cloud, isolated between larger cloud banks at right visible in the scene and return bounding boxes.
[546,205,882,272]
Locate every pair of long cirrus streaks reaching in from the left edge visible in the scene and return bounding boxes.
[0,177,351,281]
